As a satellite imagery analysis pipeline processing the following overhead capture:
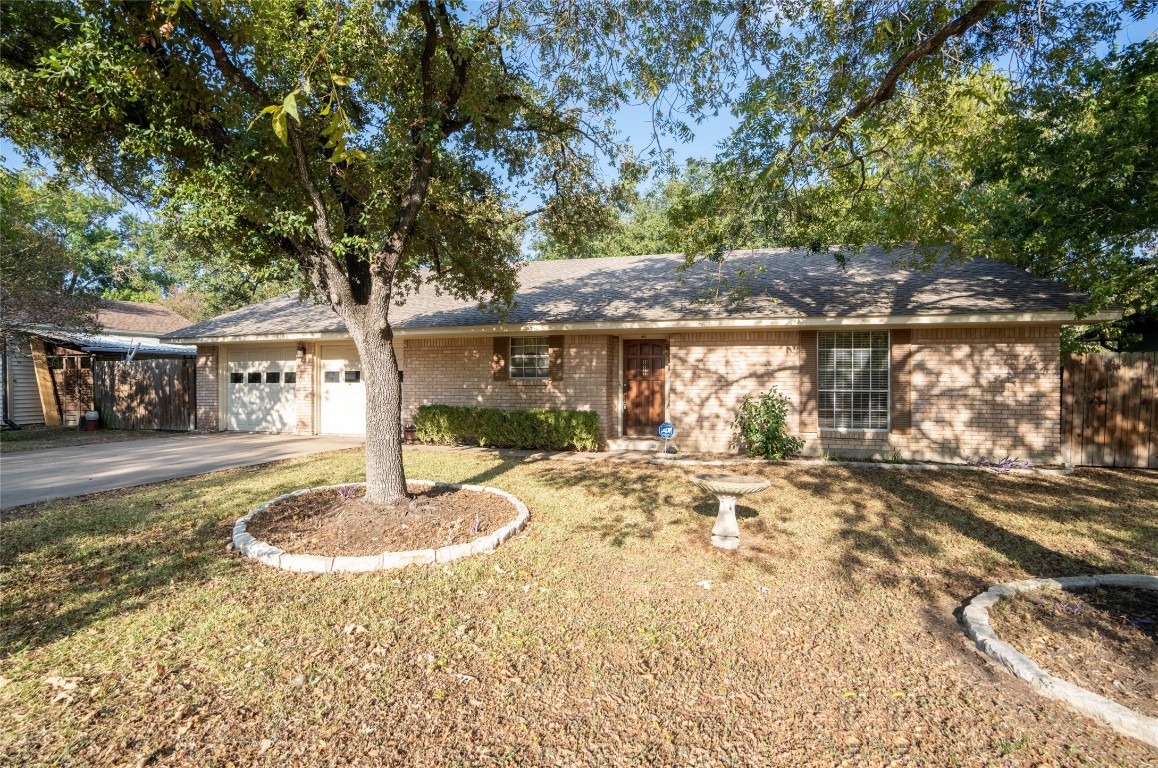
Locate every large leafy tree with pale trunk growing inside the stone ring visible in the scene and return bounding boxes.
[0,0,634,504]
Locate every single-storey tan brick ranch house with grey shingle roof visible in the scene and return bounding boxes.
[168,249,1111,461]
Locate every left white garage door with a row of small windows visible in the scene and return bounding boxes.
[226,346,298,432]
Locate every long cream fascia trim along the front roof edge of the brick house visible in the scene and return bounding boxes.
[167,312,1122,344]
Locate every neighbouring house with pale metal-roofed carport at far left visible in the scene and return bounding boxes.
[0,300,197,426]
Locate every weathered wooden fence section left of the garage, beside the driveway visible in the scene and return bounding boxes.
[93,359,197,432]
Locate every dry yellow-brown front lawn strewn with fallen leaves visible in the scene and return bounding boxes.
[0,449,1158,767]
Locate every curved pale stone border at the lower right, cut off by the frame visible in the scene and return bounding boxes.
[961,573,1158,747]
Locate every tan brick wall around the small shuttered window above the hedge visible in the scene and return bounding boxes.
[402,336,617,439]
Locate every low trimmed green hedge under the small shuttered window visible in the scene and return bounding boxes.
[415,405,600,451]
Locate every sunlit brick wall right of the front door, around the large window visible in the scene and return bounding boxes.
[668,328,1061,462]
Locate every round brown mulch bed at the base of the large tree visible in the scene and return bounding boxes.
[247,485,518,557]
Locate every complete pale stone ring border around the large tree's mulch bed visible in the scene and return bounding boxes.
[233,480,530,573]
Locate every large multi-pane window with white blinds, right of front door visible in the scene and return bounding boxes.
[816,330,889,430]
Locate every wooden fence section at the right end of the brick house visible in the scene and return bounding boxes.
[1062,352,1158,469]
